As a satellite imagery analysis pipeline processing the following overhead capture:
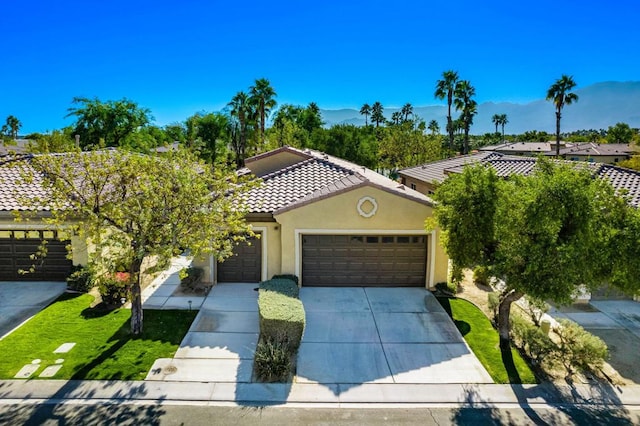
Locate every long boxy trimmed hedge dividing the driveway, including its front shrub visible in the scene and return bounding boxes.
[254,279,305,382]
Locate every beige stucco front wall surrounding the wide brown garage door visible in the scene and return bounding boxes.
[269,186,448,287]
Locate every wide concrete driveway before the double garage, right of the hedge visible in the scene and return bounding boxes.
[297,287,492,386]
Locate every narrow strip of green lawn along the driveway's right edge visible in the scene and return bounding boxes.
[438,297,536,383]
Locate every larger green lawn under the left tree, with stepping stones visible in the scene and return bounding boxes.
[0,294,197,380]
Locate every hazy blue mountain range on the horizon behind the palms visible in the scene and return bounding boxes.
[321,81,640,134]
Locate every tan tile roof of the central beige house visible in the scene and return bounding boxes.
[248,147,433,214]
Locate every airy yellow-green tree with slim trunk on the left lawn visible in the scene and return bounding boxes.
[18,150,253,334]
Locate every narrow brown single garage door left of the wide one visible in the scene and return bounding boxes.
[218,238,262,283]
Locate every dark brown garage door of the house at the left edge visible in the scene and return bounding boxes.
[0,231,72,281]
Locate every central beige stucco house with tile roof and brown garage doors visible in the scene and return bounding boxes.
[197,147,448,288]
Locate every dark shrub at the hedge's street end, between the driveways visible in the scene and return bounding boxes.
[253,337,292,382]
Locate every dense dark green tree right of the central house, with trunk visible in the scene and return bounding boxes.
[434,159,640,349]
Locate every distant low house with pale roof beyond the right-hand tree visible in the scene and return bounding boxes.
[480,141,636,164]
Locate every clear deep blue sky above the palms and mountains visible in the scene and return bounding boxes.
[0,0,640,133]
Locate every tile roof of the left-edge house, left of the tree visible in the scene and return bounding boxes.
[0,156,49,212]
